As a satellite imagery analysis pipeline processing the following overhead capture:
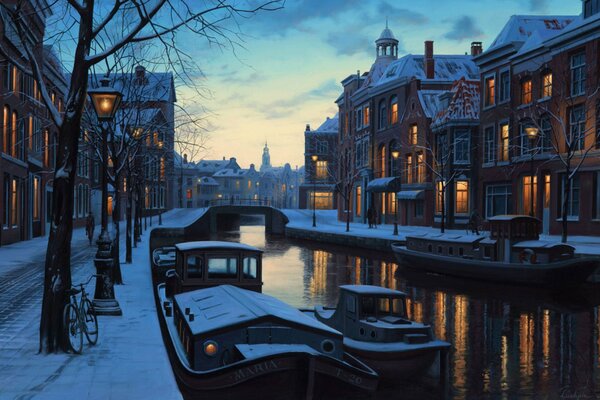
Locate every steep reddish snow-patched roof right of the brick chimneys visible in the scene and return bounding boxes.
[433,78,480,125]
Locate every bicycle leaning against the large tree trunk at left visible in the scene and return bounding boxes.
[63,275,103,354]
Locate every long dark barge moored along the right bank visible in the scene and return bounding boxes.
[392,215,599,286]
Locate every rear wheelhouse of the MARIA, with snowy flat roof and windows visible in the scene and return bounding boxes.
[167,241,263,293]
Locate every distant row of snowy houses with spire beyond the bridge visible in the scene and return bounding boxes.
[175,143,304,208]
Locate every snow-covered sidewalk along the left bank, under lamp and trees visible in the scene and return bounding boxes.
[0,210,200,400]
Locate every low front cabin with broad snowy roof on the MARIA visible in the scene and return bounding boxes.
[173,285,343,372]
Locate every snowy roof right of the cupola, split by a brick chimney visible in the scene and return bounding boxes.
[375,54,479,86]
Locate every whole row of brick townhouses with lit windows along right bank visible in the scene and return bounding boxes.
[300,0,600,234]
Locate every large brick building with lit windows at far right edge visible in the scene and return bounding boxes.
[476,4,600,234]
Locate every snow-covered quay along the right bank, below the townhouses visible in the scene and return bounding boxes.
[282,209,600,255]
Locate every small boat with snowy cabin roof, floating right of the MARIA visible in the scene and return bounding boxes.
[302,285,450,383]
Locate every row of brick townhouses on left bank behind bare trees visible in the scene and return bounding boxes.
[0,0,176,245]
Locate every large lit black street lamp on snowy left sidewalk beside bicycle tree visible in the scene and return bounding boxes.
[88,77,123,315]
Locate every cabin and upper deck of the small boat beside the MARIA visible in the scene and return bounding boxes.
[316,285,431,343]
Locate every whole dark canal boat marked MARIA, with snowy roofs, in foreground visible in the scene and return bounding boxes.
[151,242,379,399]
